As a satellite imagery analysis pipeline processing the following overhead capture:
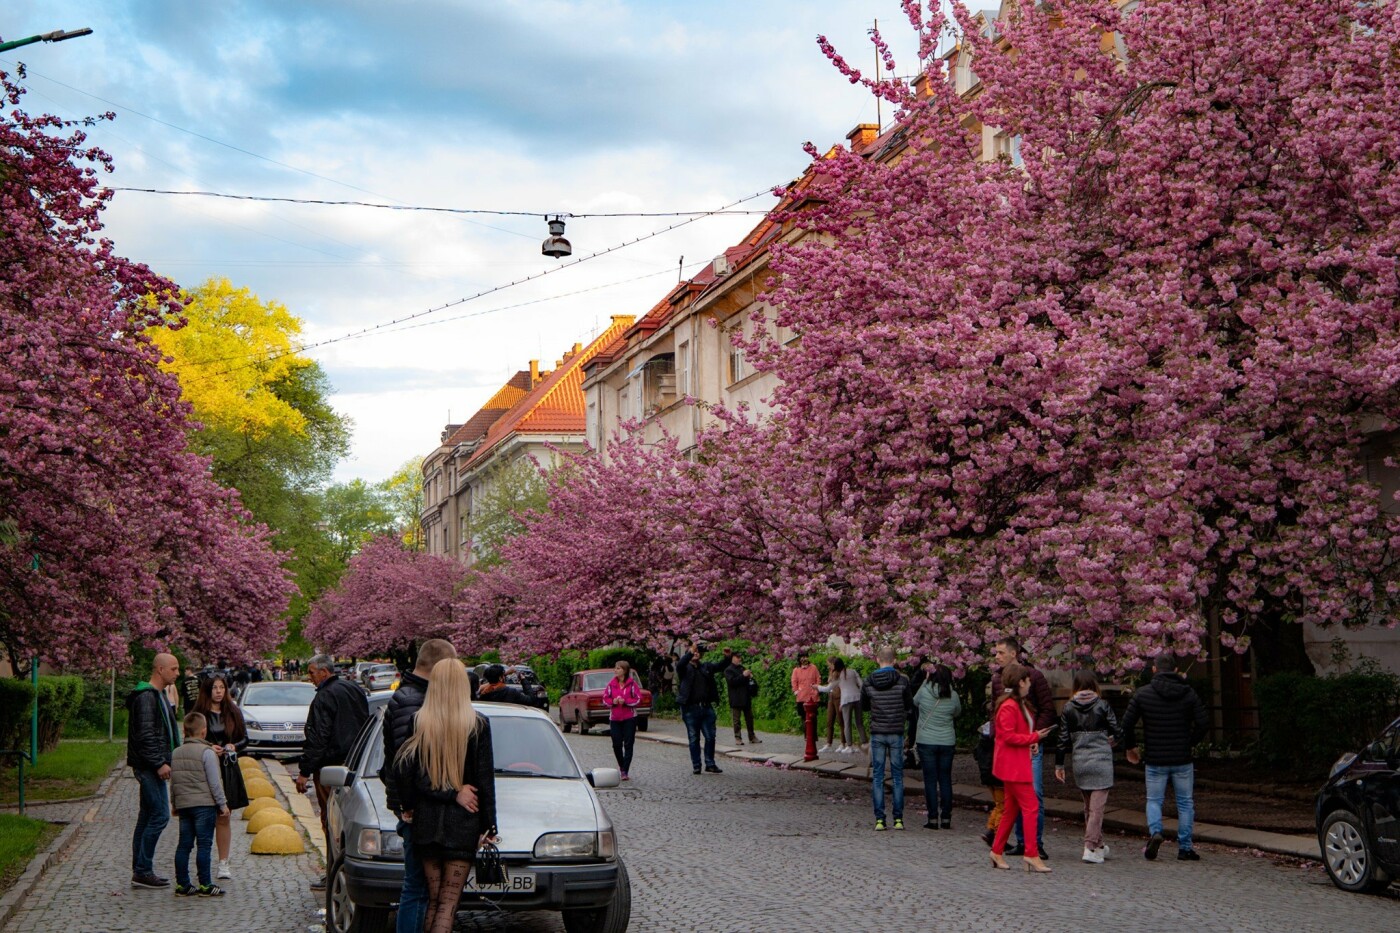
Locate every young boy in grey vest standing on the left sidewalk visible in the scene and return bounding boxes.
[171,713,228,898]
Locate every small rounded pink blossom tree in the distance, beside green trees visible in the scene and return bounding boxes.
[305,534,466,658]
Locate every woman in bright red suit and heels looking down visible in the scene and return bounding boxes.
[991,664,1054,871]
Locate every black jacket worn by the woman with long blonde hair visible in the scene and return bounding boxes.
[393,716,496,853]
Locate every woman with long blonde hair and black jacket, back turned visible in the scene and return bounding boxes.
[393,658,496,933]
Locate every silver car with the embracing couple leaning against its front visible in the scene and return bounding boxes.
[321,693,631,933]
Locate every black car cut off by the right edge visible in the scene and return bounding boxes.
[1317,719,1400,892]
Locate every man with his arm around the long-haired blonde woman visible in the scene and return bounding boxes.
[379,639,464,933]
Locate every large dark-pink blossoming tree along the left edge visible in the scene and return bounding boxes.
[0,73,290,668]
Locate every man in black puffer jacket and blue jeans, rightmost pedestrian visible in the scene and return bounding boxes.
[1123,654,1208,862]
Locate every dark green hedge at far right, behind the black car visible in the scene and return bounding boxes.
[1254,670,1400,772]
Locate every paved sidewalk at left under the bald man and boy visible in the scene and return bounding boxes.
[4,766,322,933]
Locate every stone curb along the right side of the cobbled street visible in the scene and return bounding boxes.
[637,733,1322,862]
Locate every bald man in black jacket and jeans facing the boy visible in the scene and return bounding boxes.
[126,654,179,888]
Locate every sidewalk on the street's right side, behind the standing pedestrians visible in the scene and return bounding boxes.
[637,717,1322,860]
